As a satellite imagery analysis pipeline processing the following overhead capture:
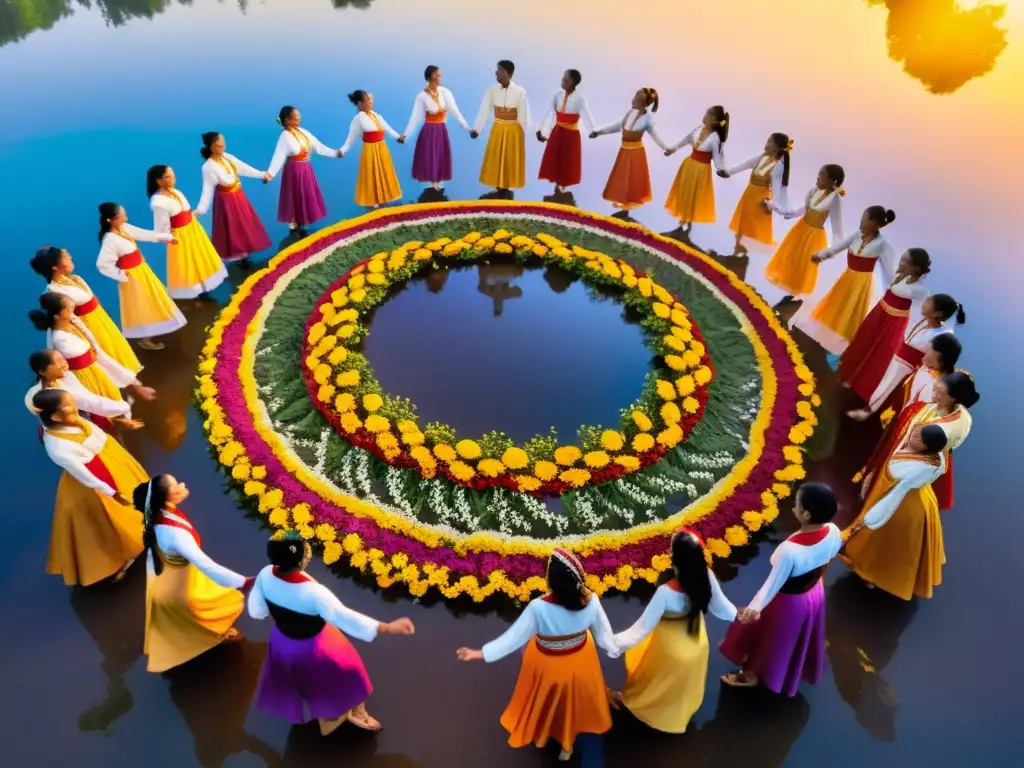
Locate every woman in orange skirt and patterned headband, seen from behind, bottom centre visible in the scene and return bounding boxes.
[458,549,620,761]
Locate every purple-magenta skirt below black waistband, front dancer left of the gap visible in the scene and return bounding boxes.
[256,625,374,724]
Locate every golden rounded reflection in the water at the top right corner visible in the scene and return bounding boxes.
[865,0,1007,93]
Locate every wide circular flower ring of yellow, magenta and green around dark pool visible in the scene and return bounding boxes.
[197,202,819,600]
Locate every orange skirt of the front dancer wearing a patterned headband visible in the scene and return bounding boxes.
[502,633,611,750]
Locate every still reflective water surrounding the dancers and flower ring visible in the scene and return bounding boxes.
[0,0,1024,768]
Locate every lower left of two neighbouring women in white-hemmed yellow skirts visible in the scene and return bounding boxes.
[96,203,185,350]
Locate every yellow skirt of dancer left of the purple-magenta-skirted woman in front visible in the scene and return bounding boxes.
[143,553,245,672]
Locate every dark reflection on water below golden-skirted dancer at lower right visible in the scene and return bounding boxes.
[826,573,918,741]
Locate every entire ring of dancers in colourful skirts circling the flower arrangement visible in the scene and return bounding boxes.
[26,61,979,759]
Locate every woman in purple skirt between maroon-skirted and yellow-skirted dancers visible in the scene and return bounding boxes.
[266,106,341,231]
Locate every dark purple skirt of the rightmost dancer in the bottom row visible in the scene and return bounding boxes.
[721,581,825,696]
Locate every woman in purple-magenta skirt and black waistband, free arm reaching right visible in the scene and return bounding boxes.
[249,531,415,736]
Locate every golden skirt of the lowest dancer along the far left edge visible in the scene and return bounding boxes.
[46,438,150,587]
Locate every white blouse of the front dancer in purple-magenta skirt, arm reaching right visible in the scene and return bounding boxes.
[249,565,380,643]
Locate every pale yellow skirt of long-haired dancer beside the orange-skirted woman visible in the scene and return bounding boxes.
[623,616,708,733]
